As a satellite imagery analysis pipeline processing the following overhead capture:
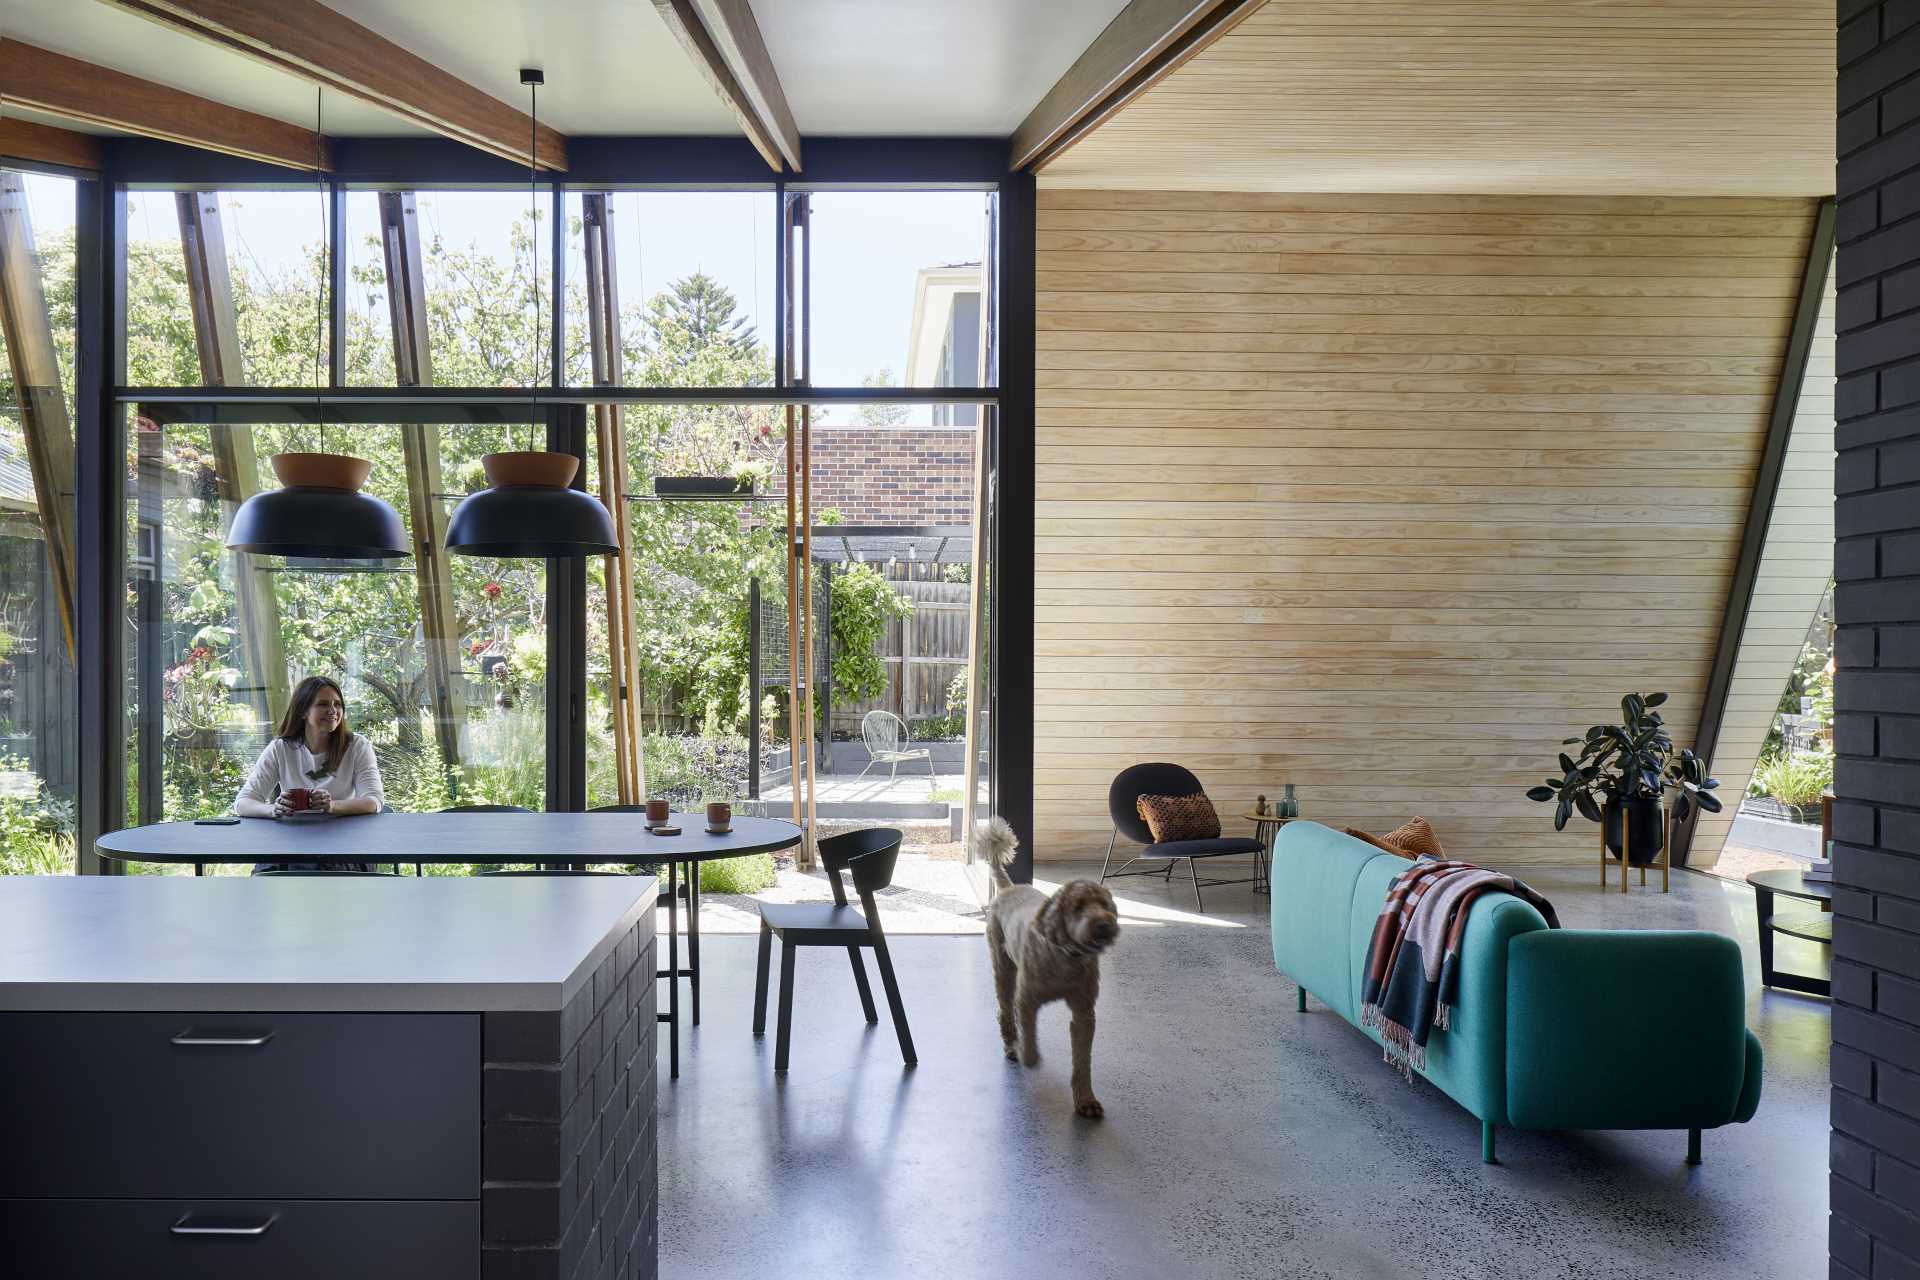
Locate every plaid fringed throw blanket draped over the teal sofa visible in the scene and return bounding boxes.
[1359,860,1559,1080]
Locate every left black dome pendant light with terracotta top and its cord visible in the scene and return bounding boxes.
[227,90,409,560]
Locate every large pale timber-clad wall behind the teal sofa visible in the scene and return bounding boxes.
[1035,188,1814,864]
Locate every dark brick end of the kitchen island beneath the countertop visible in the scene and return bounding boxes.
[480,912,660,1280]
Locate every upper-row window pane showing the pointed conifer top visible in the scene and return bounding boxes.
[566,192,780,386]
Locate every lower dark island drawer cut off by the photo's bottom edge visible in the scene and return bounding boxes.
[0,1199,480,1280]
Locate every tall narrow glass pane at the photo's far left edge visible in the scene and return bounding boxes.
[0,171,79,875]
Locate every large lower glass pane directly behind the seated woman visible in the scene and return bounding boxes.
[127,420,547,871]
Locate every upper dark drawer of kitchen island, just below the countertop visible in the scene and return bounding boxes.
[0,1013,480,1199]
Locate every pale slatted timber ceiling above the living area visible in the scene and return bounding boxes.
[1041,0,1834,196]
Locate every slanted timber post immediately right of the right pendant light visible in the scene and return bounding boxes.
[580,192,647,804]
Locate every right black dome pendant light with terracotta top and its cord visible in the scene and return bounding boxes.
[447,67,618,558]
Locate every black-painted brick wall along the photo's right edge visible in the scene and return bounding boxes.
[1830,0,1920,1280]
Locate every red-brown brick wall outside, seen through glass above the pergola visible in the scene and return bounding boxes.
[774,426,973,524]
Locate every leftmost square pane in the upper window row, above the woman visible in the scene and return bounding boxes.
[127,188,328,386]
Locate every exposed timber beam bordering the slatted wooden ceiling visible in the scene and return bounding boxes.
[1008,0,1265,169]
